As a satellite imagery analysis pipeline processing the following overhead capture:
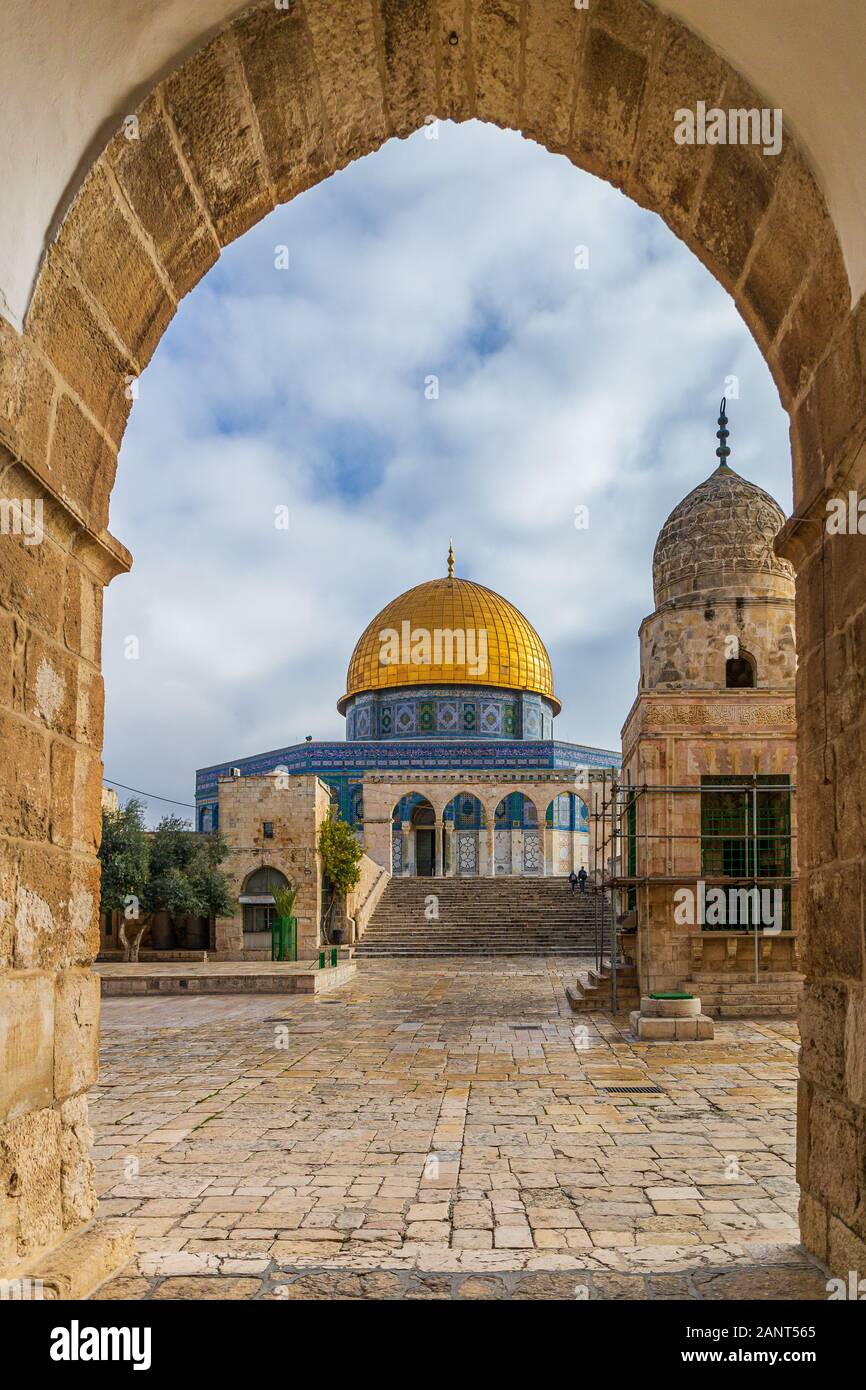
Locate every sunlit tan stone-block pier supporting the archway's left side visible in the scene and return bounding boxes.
[0,448,128,1269]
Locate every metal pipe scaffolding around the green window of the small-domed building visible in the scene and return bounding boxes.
[589,770,798,1011]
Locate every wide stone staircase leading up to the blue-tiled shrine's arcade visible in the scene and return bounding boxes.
[356,877,598,959]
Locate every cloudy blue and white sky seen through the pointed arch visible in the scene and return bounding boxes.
[104,122,791,819]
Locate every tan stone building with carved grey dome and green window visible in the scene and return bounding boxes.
[616,402,799,1013]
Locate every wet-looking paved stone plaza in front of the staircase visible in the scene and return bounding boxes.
[92,959,826,1298]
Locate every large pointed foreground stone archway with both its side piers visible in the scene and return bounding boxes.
[0,0,866,1270]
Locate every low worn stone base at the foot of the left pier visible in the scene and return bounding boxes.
[4,1218,135,1300]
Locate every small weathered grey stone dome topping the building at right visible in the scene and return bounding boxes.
[652,461,794,609]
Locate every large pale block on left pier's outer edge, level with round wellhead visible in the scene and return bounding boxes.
[0,970,54,1122]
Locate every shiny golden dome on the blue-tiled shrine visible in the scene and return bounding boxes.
[336,556,560,714]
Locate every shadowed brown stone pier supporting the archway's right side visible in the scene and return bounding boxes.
[781,444,866,1277]
